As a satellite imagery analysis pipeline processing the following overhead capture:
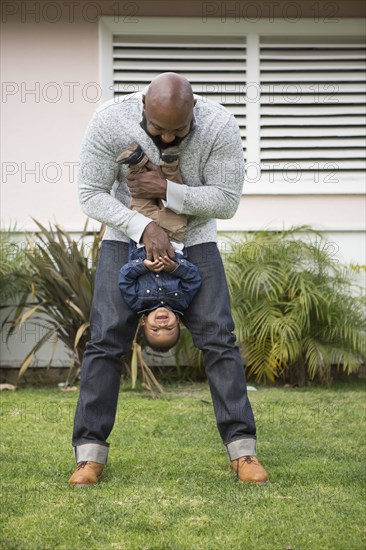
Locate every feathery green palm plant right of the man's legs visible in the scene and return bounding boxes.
[225,227,366,382]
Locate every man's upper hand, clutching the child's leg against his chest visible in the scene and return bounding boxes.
[127,161,167,200]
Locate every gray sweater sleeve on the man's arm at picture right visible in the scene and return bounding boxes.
[166,115,244,219]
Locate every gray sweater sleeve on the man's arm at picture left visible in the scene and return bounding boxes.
[78,111,151,242]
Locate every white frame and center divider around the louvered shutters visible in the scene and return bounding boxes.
[99,16,366,195]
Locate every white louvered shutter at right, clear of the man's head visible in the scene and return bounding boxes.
[260,36,366,188]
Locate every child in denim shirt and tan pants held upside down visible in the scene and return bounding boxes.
[117,144,201,351]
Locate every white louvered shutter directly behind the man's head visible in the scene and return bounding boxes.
[113,36,246,147]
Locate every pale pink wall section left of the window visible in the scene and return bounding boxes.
[1,12,100,233]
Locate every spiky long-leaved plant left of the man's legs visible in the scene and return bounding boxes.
[3,220,104,384]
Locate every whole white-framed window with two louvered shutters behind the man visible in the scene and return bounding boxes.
[102,18,366,194]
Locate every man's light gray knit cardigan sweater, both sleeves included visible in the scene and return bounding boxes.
[78,92,244,246]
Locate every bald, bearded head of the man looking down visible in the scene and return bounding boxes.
[142,73,196,147]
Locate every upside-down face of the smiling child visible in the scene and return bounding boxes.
[141,307,179,347]
